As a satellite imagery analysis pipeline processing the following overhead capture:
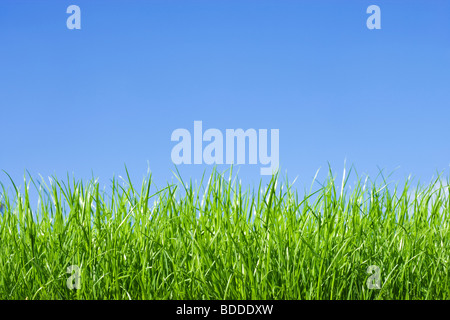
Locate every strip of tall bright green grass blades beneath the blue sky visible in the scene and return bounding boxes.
[0,171,450,299]
